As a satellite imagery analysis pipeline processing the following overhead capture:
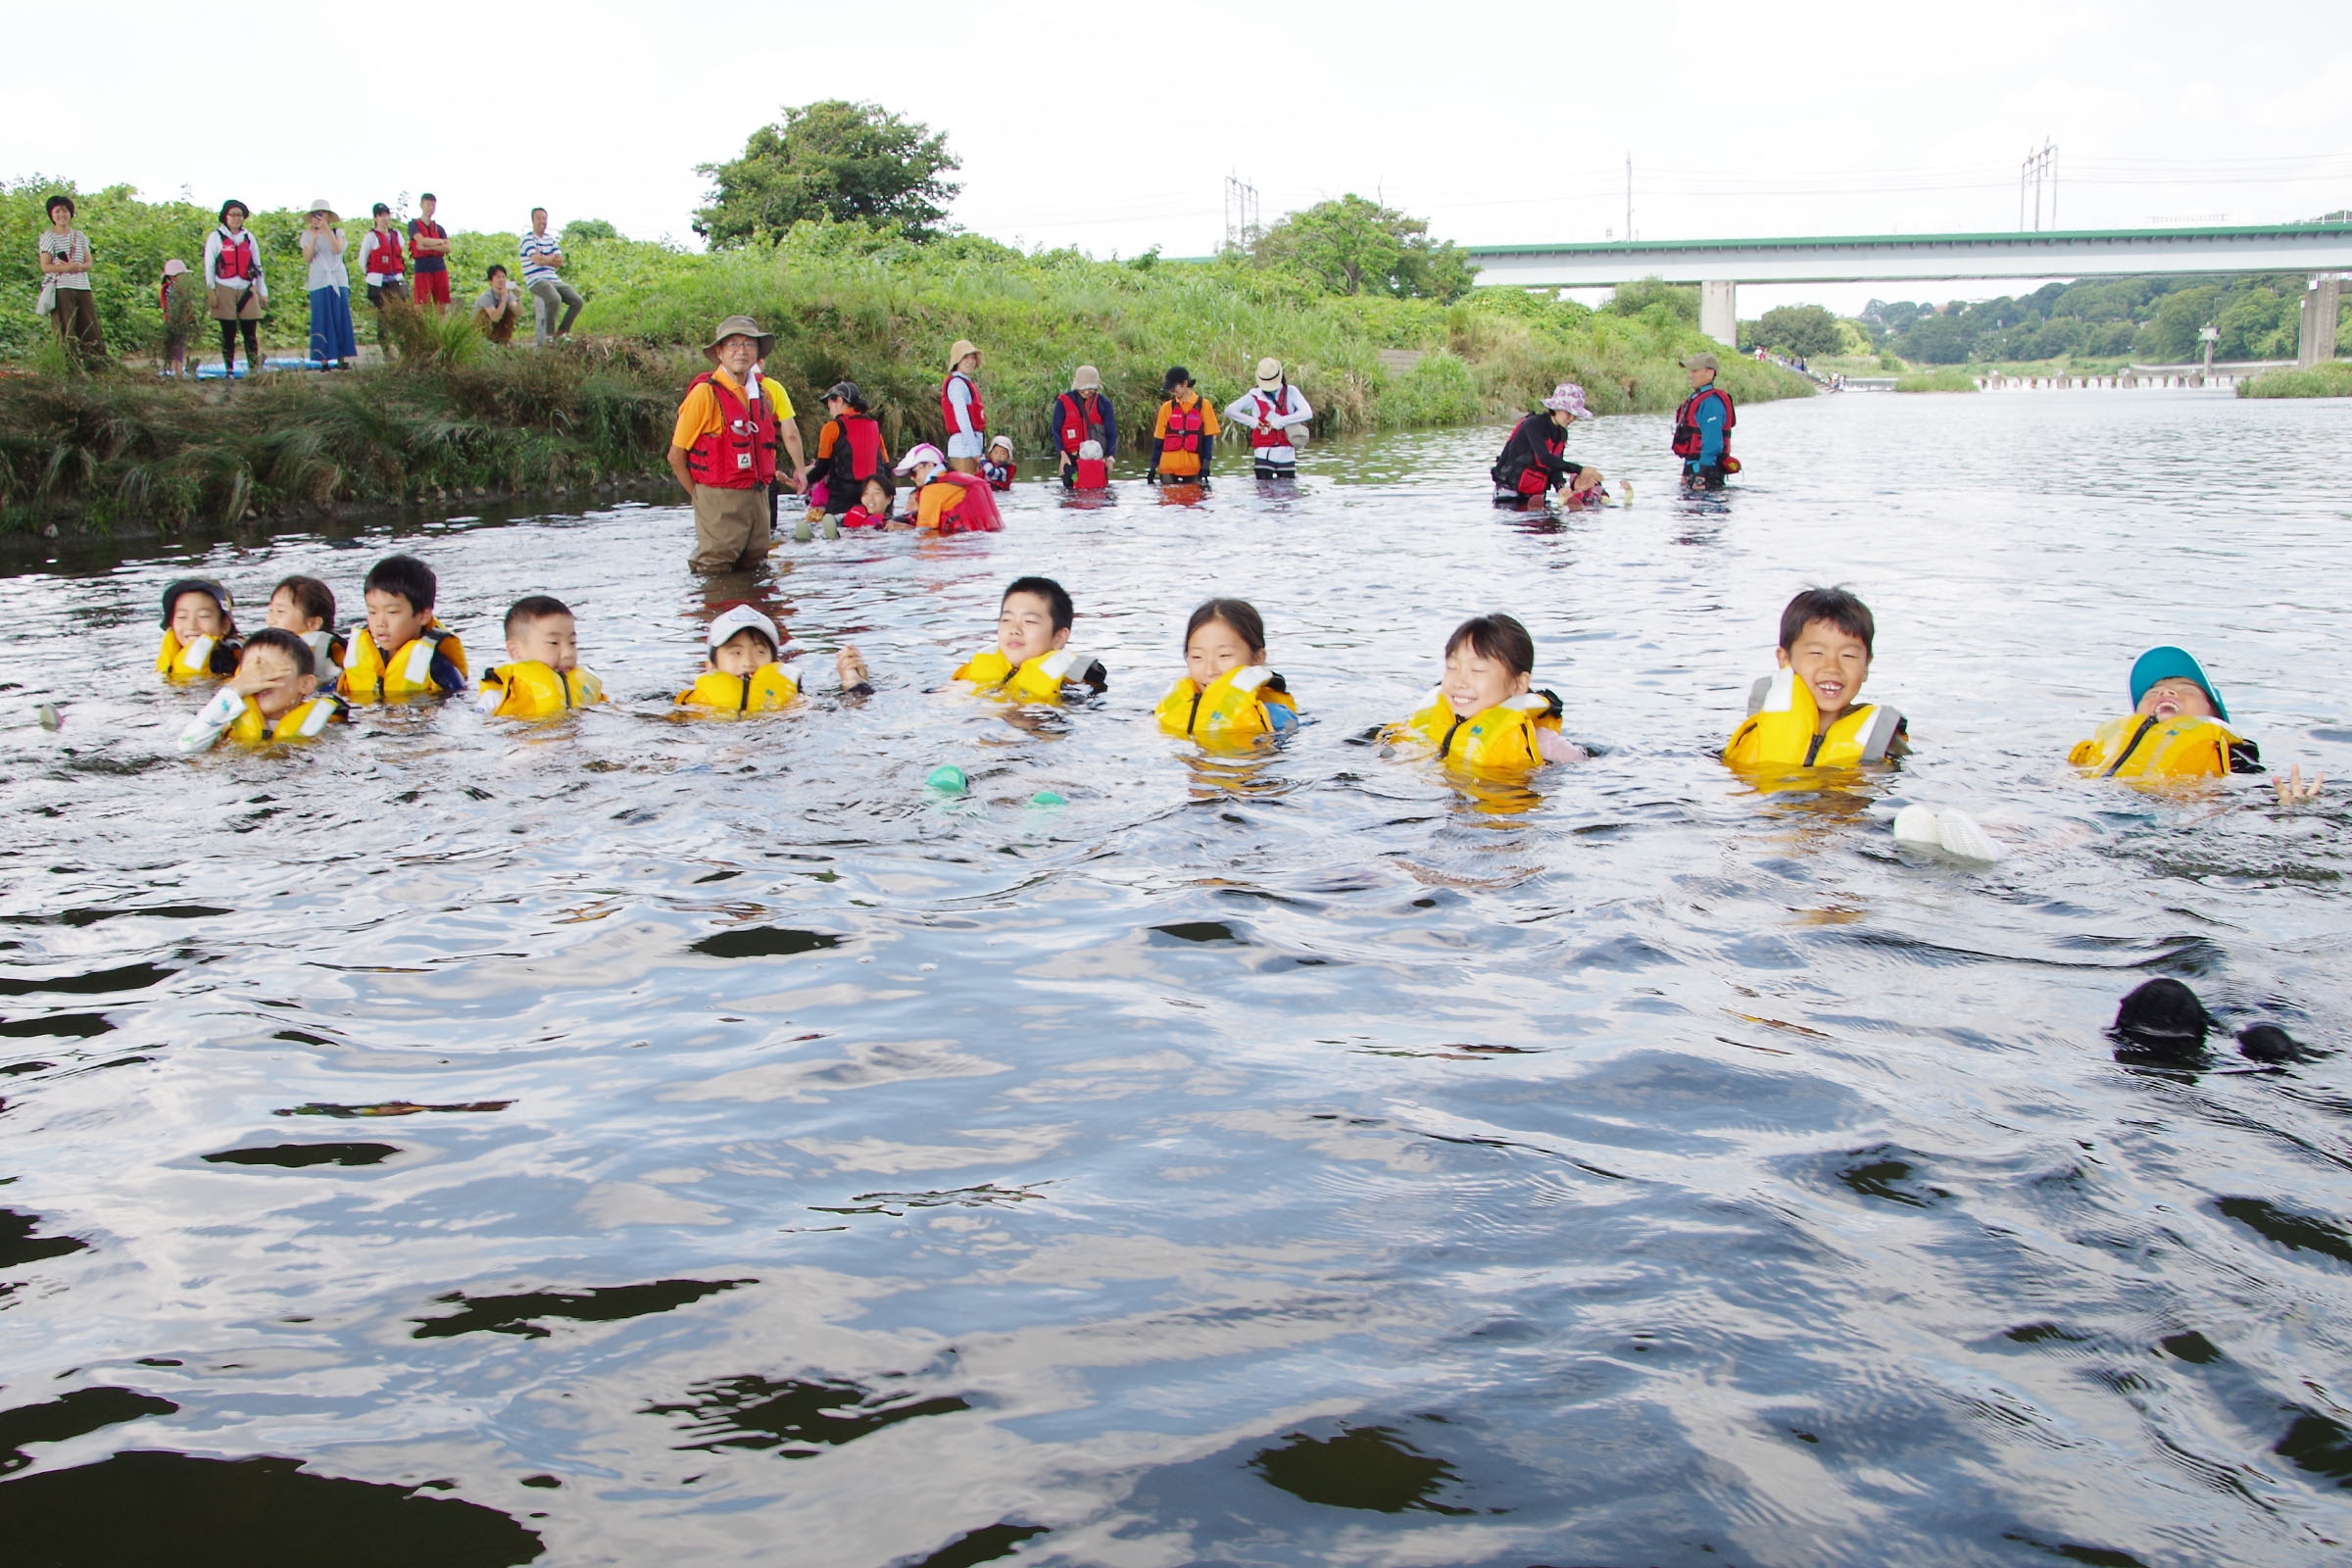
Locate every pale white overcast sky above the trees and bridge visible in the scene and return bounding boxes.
[0,0,2352,315]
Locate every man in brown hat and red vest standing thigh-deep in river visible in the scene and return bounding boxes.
[670,315,809,571]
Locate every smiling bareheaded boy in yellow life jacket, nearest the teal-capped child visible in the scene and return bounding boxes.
[1724,588,1910,773]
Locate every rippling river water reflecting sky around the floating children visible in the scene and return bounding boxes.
[0,393,2352,1568]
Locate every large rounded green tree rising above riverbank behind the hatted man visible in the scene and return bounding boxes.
[694,99,962,247]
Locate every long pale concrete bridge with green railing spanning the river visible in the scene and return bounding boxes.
[1465,223,2352,365]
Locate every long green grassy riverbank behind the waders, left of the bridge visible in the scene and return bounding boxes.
[0,190,1811,531]
